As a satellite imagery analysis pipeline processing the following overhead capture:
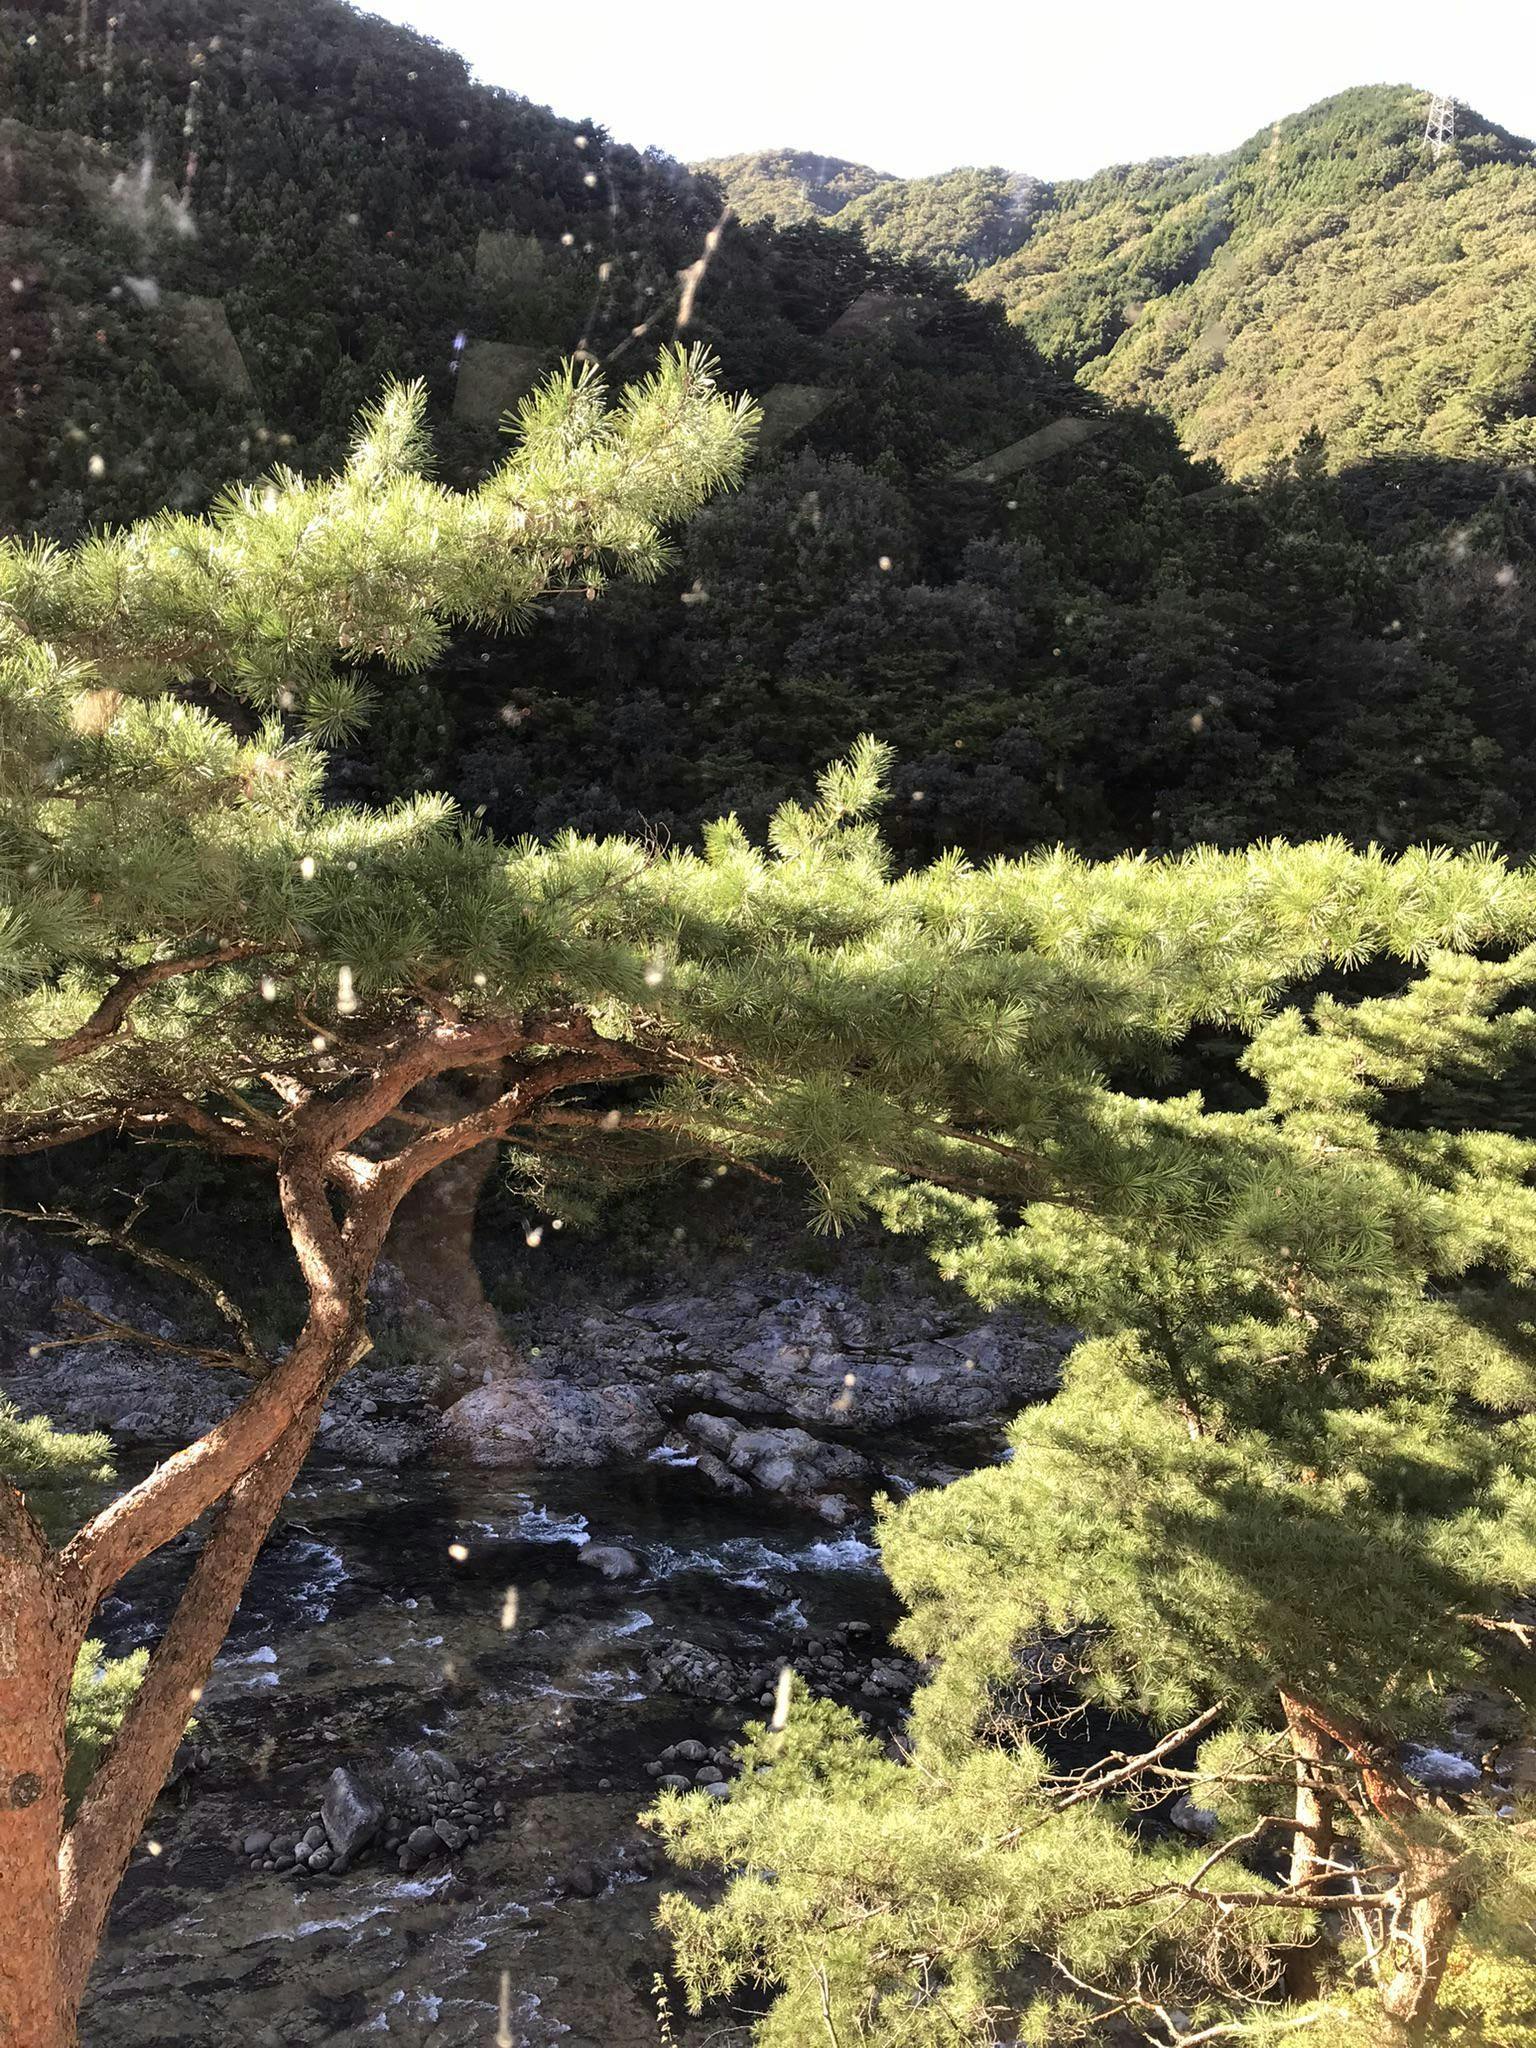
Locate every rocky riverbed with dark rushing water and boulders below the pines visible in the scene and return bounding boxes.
[0,1190,1069,2048]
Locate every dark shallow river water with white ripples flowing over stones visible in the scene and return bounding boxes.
[82,1460,909,2048]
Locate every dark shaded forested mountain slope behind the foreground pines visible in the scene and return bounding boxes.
[0,0,1536,856]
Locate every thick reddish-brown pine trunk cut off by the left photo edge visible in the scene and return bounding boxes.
[0,1515,78,2048]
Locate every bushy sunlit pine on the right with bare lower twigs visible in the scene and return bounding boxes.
[655,872,1536,2048]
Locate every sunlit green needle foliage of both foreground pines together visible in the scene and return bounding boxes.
[0,331,1536,2044]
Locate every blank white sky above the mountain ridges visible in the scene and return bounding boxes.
[352,0,1536,178]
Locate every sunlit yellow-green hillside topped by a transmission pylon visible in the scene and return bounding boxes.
[973,86,1536,475]
